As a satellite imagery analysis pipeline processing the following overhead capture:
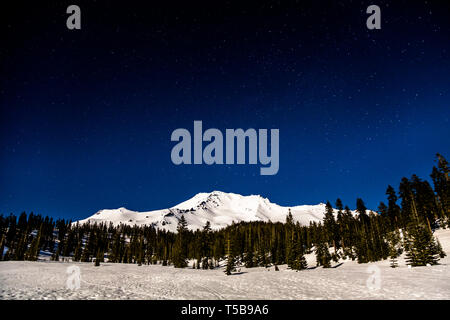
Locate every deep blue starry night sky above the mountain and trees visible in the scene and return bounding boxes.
[0,0,450,219]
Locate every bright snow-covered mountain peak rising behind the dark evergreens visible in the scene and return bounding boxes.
[75,191,360,231]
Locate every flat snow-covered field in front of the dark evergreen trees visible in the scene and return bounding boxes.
[0,230,450,299]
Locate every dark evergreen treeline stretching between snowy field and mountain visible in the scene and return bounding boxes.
[0,154,450,274]
